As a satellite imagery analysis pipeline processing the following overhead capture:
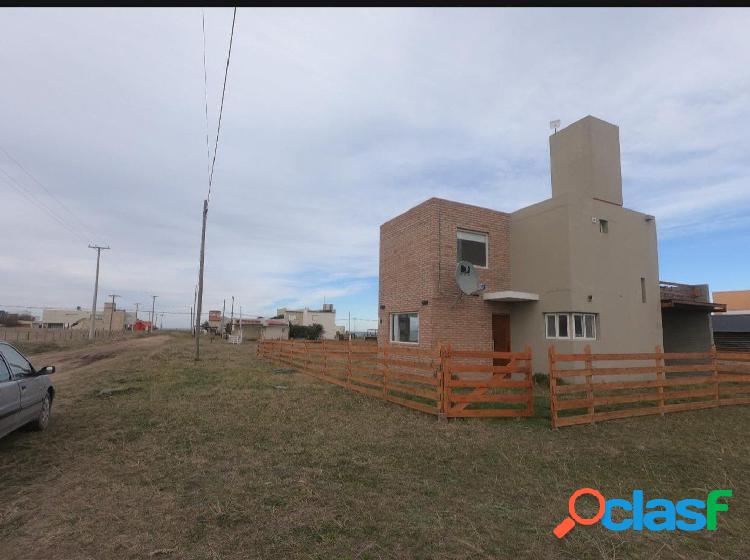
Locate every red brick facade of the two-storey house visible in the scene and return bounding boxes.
[378,198,511,350]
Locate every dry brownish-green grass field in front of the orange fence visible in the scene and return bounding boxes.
[0,335,750,559]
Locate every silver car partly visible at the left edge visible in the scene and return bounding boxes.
[0,341,55,437]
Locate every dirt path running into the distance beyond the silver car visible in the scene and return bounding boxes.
[29,335,170,382]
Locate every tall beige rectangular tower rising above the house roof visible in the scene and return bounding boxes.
[549,116,622,206]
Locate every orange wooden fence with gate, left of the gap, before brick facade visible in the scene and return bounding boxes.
[258,340,533,417]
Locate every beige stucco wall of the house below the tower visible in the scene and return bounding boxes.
[510,195,663,372]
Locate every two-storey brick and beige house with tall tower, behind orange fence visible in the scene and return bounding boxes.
[378,116,692,372]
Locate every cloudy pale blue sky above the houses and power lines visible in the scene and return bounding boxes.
[0,8,750,330]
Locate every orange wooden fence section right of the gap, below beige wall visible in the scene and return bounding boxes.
[549,346,750,428]
